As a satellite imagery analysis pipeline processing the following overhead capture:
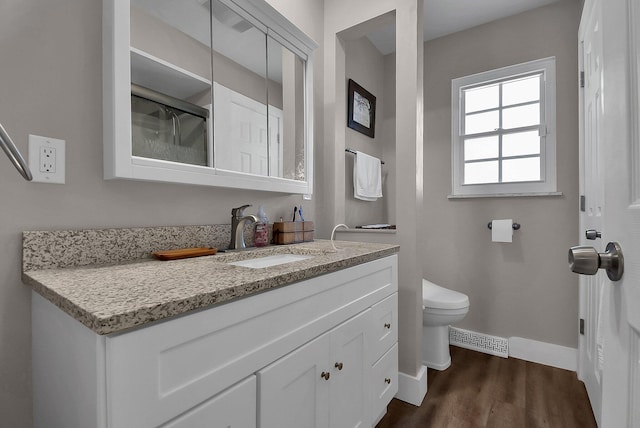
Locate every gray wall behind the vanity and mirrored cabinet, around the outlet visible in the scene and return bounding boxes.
[0,0,323,428]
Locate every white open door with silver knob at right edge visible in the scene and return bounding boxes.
[579,0,640,427]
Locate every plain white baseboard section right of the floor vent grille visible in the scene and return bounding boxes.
[509,337,578,372]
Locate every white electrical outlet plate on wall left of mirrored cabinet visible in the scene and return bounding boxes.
[29,135,65,184]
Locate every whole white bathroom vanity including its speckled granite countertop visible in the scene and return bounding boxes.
[23,234,398,428]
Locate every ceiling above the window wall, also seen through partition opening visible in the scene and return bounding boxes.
[367,0,559,55]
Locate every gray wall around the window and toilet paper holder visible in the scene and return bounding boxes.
[423,0,580,348]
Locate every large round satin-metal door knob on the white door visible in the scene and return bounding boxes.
[569,242,624,281]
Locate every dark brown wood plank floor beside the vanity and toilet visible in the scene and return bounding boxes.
[377,346,597,428]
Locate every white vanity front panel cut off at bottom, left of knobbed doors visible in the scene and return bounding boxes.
[162,376,256,428]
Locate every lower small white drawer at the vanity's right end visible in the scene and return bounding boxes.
[370,343,398,415]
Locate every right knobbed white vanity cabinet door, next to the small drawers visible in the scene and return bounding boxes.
[329,309,371,428]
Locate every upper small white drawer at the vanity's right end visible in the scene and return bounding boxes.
[370,293,398,364]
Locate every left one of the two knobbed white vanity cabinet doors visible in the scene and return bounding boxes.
[258,333,333,428]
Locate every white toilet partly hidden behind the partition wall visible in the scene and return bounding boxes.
[422,279,469,370]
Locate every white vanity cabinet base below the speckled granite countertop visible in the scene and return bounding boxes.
[32,255,398,428]
